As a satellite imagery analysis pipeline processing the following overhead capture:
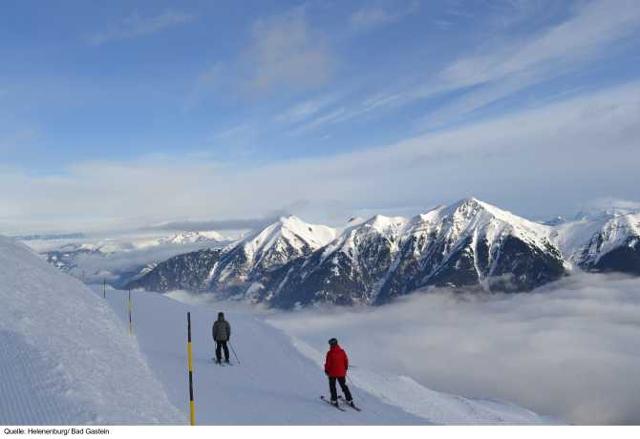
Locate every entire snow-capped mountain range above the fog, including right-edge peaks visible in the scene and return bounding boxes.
[127,198,640,309]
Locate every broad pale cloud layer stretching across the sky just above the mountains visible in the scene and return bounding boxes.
[0,83,640,233]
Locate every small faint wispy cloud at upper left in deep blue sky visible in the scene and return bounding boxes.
[89,10,195,45]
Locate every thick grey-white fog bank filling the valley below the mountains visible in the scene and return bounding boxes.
[271,274,640,424]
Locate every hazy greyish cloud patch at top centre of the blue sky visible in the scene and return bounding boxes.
[248,8,334,91]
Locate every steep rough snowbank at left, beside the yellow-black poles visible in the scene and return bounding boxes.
[0,237,183,425]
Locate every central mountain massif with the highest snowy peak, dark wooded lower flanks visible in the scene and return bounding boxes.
[265,198,565,308]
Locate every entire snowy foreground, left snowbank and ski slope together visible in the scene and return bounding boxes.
[0,238,544,425]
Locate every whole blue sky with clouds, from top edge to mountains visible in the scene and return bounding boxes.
[0,0,640,234]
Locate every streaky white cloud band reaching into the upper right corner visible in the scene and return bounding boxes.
[416,0,640,126]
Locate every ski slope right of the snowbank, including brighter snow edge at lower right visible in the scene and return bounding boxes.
[107,290,545,425]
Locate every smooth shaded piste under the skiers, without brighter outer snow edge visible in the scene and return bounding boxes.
[104,290,430,425]
